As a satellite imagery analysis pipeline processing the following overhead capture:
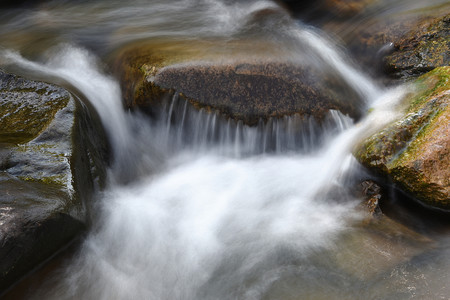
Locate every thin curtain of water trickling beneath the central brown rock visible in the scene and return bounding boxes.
[142,94,353,157]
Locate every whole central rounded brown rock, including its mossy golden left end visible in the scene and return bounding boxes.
[114,43,363,125]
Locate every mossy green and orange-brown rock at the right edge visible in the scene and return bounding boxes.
[355,67,450,210]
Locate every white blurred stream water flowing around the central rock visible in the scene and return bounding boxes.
[0,0,450,299]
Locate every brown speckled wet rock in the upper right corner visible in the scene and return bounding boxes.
[320,2,450,79]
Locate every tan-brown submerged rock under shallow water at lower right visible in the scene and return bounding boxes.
[330,214,436,282]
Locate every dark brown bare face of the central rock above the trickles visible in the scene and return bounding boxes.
[151,64,359,125]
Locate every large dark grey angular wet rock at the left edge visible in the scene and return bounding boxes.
[0,70,107,292]
